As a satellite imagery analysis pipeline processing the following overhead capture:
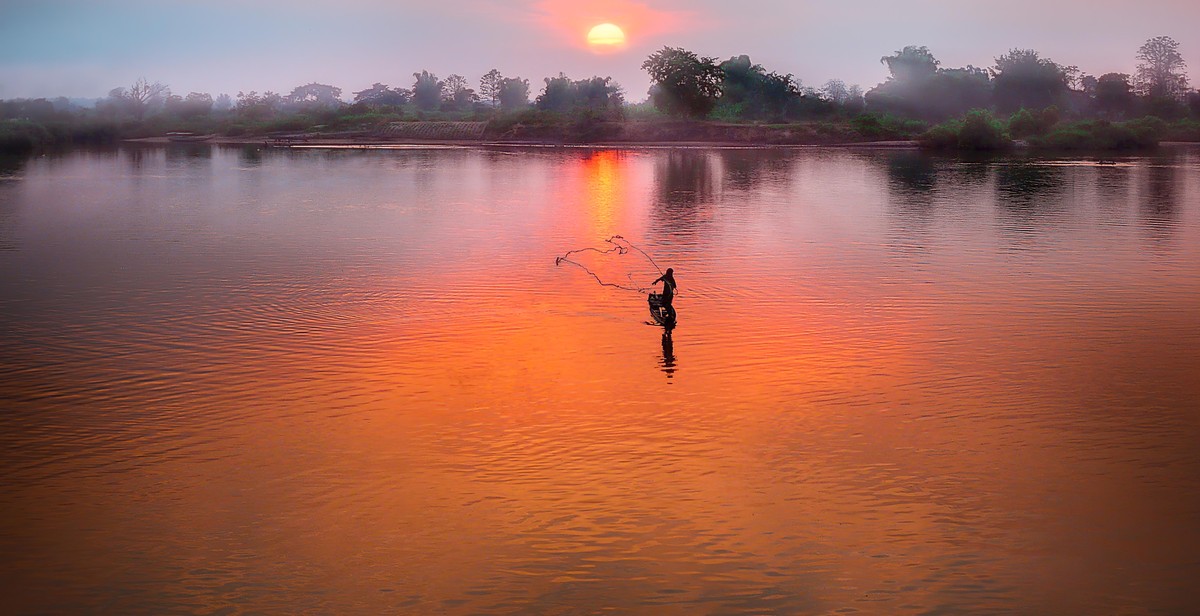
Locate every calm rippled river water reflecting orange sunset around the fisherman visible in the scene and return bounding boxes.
[0,146,1200,614]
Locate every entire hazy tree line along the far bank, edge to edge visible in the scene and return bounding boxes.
[0,36,1200,153]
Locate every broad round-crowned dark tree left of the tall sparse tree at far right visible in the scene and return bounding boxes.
[991,49,1068,112]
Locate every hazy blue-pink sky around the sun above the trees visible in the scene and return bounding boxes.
[0,0,1200,102]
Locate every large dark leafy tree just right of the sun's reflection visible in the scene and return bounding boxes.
[642,47,725,118]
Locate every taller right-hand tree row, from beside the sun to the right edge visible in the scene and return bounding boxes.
[642,36,1200,121]
